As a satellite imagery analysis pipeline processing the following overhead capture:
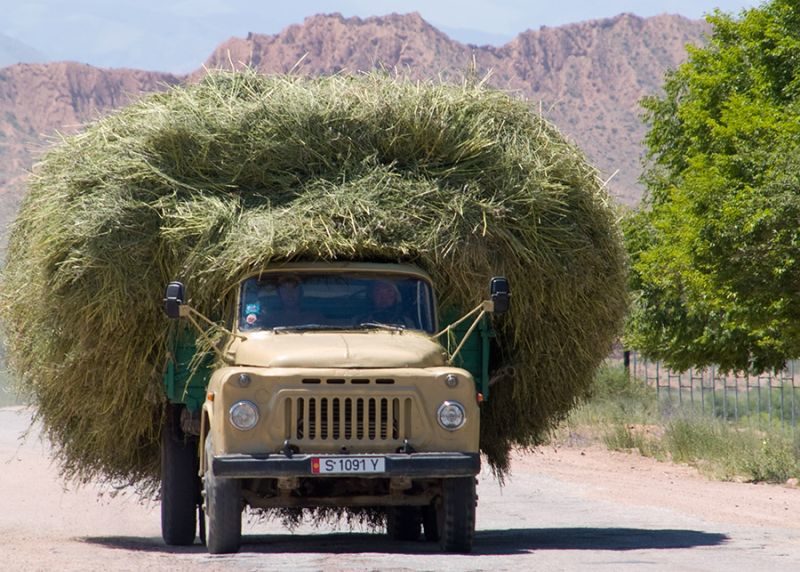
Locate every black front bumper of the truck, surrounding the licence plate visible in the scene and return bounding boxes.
[211,453,481,479]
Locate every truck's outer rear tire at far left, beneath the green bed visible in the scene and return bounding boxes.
[161,406,200,546]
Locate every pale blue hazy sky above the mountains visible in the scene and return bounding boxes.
[0,0,761,73]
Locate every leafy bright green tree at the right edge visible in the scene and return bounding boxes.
[625,0,800,371]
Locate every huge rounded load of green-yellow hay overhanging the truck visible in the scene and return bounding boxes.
[2,72,625,488]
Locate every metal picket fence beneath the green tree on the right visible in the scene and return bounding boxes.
[626,352,800,429]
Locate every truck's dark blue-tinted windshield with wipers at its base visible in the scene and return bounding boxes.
[239,272,436,333]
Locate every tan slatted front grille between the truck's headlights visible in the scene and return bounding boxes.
[285,396,412,443]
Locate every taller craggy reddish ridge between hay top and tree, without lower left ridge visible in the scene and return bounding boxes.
[205,14,708,204]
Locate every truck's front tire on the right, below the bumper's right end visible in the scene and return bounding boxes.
[436,477,477,553]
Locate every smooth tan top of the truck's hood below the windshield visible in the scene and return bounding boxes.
[225,331,446,369]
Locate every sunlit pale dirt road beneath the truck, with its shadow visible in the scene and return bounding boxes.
[0,408,800,572]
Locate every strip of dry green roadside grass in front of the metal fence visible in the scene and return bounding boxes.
[556,365,800,483]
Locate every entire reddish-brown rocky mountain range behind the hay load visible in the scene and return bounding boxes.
[0,10,708,227]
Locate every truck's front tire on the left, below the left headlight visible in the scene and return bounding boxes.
[203,435,242,554]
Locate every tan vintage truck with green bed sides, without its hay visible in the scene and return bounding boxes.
[161,262,510,554]
